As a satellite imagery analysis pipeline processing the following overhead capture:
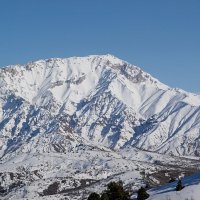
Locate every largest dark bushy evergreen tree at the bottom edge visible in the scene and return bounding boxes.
[106,182,130,200]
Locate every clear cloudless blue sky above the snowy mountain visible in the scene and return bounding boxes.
[0,0,200,92]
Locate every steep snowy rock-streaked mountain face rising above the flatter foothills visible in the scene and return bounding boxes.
[0,55,200,157]
